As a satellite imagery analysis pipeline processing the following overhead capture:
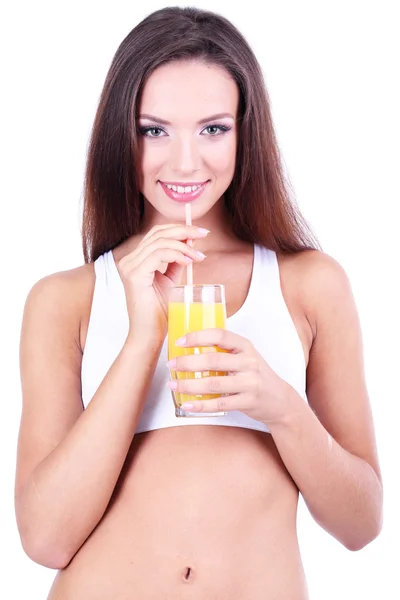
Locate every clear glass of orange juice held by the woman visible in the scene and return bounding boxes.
[168,284,226,417]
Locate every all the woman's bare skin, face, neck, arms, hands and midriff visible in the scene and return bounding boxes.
[16,58,382,600]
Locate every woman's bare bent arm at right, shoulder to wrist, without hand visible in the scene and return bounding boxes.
[268,252,383,550]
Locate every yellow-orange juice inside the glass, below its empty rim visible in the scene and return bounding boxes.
[168,302,226,406]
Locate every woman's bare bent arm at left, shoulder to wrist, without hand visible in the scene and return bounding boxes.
[15,267,162,569]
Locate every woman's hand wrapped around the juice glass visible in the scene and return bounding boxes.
[168,329,293,426]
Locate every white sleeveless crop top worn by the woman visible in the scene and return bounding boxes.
[81,244,306,433]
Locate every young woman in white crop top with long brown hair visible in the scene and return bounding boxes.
[16,8,382,600]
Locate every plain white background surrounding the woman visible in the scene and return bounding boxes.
[0,0,400,600]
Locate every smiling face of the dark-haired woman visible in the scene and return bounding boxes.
[137,61,239,223]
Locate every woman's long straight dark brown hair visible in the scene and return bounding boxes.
[82,7,320,262]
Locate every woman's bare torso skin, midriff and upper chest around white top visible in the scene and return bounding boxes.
[49,243,312,600]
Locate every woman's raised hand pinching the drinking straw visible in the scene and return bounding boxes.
[118,224,208,341]
